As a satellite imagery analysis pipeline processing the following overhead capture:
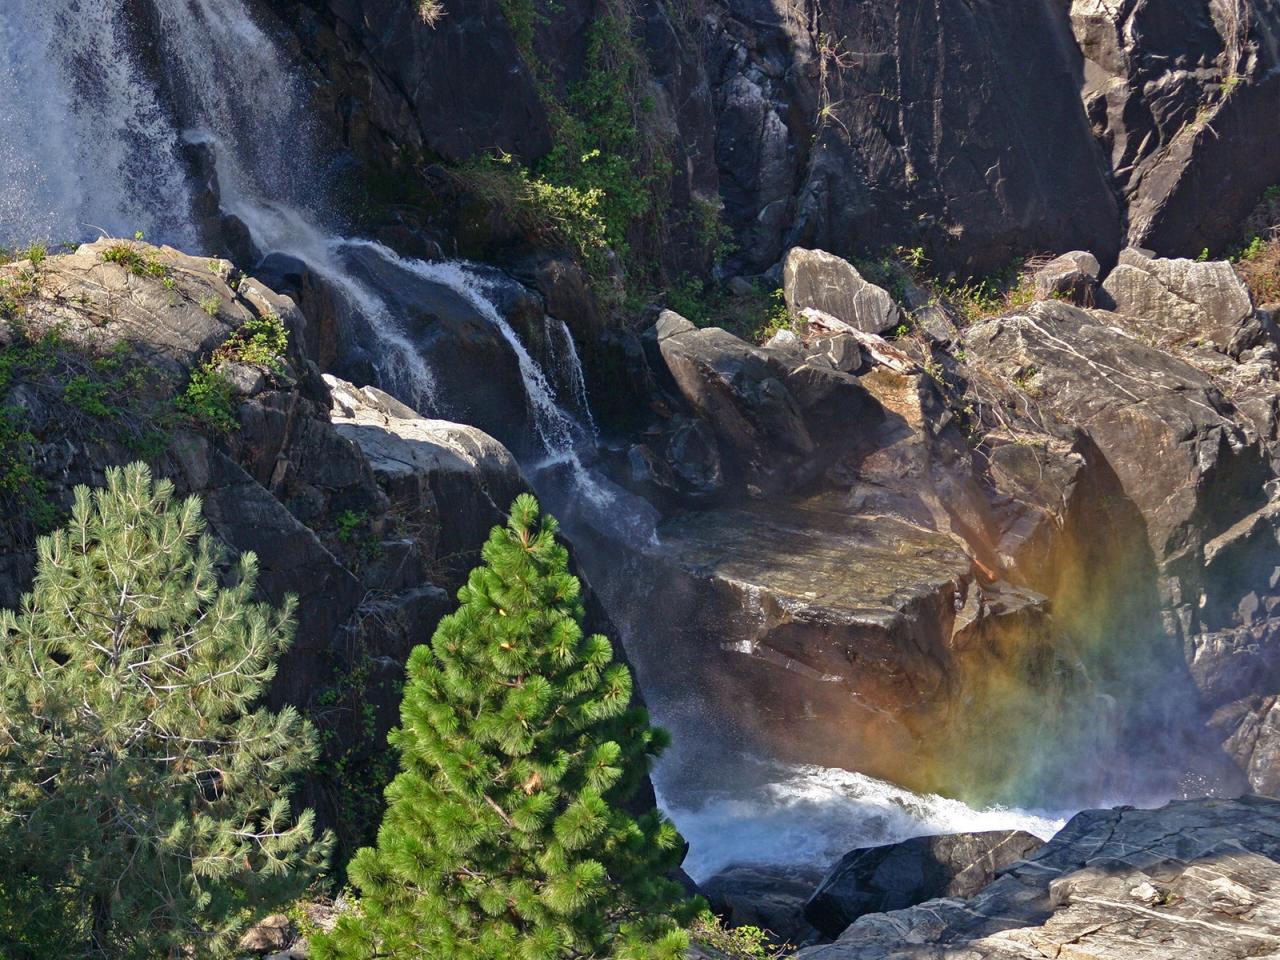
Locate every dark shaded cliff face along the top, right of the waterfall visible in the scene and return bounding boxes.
[260,0,1280,274]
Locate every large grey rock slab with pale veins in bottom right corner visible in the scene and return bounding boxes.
[797,796,1280,960]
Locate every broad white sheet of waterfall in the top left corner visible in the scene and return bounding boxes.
[0,0,196,247]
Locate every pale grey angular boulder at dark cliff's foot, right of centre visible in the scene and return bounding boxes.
[782,247,902,333]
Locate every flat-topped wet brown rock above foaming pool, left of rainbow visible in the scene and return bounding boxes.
[653,497,1069,788]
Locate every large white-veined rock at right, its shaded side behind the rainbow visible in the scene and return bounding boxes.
[964,302,1280,790]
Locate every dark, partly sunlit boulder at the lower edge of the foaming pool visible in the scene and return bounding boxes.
[804,831,1044,938]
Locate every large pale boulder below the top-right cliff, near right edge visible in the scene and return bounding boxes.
[1102,247,1261,356]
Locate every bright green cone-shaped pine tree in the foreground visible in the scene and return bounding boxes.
[312,494,692,960]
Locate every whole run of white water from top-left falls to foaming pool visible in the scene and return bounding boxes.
[0,0,1090,878]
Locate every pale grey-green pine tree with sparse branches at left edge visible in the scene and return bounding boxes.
[0,463,329,960]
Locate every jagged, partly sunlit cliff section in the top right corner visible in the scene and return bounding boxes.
[1070,0,1280,256]
